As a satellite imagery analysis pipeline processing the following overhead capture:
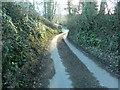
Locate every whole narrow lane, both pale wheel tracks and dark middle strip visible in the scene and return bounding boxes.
[49,29,118,88]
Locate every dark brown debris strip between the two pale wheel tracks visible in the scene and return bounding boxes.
[57,36,101,88]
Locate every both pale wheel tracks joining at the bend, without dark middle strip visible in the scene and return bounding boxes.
[49,29,118,88]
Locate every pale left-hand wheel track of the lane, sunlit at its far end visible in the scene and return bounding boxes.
[49,34,72,88]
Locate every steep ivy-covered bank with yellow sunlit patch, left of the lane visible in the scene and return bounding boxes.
[2,2,61,88]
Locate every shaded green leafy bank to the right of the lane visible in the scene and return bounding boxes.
[67,2,120,73]
